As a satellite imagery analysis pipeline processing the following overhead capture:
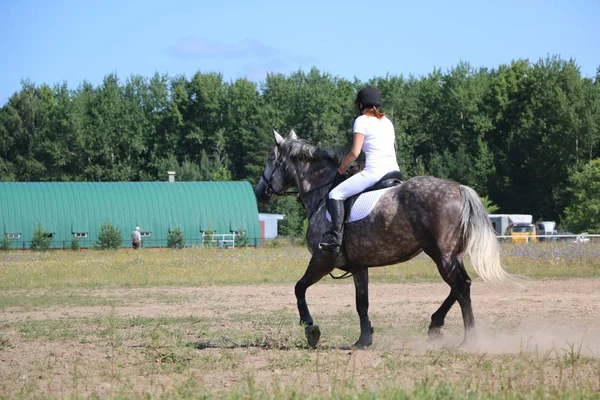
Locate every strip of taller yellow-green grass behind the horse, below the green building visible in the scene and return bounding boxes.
[0,242,600,292]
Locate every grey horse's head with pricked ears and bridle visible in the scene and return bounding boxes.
[254,130,298,203]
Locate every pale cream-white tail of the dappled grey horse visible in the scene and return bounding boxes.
[460,185,513,281]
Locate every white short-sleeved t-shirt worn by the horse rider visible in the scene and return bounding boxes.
[353,115,400,172]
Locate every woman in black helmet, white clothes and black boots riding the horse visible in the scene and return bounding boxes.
[319,86,400,252]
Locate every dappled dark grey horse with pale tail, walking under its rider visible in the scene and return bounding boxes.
[255,130,513,349]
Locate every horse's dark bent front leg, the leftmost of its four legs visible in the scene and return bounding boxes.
[294,250,335,347]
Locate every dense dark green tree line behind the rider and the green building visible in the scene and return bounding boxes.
[0,57,600,235]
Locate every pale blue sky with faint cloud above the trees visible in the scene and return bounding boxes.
[0,0,600,105]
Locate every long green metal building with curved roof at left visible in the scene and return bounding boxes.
[0,182,261,248]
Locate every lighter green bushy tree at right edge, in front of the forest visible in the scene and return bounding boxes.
[563,158,600,234]
